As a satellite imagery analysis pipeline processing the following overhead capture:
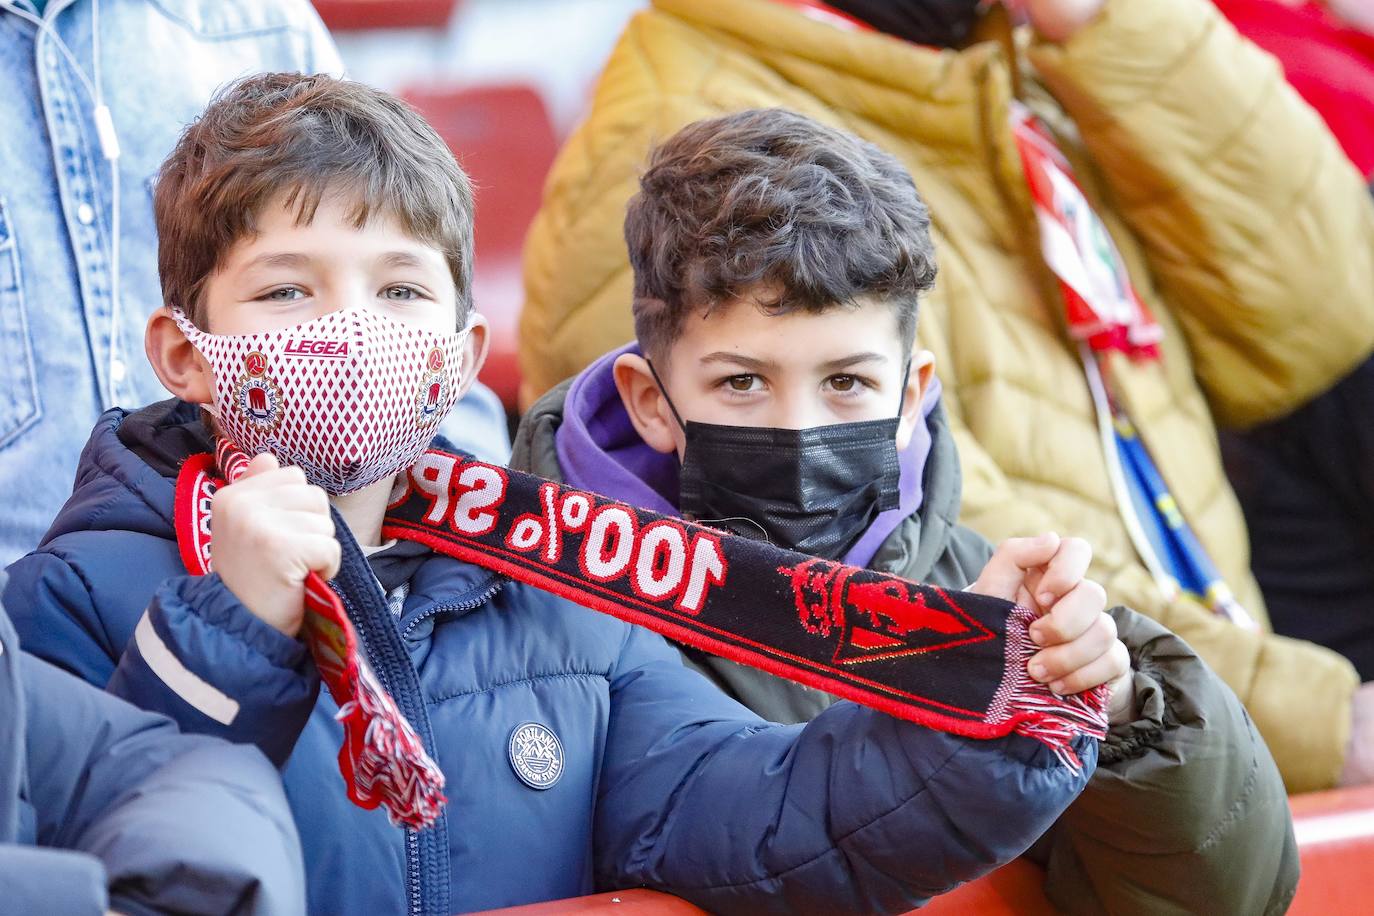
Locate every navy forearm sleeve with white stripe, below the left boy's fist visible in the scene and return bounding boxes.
[107,573,320,766]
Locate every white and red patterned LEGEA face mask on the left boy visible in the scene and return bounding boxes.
[172,308,473,494]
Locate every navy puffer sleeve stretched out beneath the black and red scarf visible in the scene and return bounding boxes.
[594,628,1096,913]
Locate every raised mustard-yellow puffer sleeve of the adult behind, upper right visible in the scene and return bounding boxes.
[1031,0,1374,426]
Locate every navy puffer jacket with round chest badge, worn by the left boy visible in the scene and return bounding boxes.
[5,402,1096,913]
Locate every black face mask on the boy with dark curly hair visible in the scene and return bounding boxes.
[650,364,905,560]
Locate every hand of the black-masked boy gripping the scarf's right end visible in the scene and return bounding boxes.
[969,533,1135,724]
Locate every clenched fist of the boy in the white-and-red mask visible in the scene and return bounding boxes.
[210,453,341,637]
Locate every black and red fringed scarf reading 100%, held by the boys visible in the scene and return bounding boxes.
[177,441,1107,825]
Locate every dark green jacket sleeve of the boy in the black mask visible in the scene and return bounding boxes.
[1031,607,1298,916]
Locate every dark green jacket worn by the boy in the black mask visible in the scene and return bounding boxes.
[511,382,1298,916]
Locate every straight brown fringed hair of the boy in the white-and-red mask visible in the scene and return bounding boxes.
[153,73,473,327]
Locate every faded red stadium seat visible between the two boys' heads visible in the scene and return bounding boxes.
[401,85,558,409]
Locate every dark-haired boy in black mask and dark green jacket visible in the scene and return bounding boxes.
[513,110,1297,913]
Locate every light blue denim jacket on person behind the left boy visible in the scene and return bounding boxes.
[0,0,507,584]
